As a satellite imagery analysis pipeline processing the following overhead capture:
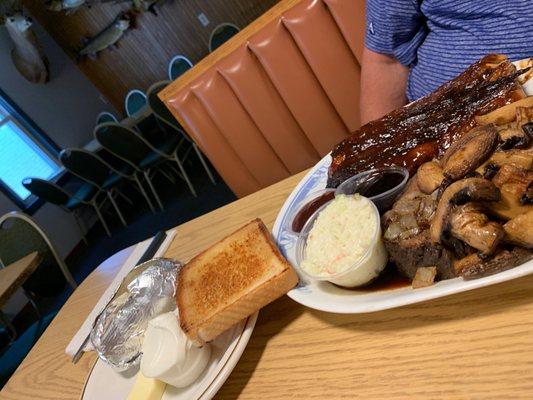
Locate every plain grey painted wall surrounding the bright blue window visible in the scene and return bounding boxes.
[0,16,115,316]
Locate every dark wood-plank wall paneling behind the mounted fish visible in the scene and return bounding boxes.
[24,0,278,110]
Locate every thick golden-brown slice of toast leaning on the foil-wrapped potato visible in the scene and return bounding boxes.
[176,219,298,345]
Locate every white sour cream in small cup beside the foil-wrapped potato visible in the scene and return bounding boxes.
[141,312,211,387]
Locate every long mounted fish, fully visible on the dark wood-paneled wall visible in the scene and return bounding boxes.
[77,12,135,60]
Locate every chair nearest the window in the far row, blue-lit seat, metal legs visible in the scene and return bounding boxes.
[22,178,111,238]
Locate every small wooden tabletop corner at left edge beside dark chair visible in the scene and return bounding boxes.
[0,251,41,307]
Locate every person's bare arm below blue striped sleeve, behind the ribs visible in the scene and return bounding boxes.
[359,47,409,125]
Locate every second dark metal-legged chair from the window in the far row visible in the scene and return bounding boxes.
[59,149,131,226]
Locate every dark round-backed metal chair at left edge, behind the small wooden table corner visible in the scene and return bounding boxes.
[0,211,77,339]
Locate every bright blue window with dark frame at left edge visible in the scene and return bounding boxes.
[0,93,61,209]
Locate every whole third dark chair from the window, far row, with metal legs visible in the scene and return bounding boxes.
[94,122,169,212]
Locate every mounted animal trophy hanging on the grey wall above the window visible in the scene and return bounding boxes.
[4,12,50,83]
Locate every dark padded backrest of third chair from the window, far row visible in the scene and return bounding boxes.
[94,122,152,168]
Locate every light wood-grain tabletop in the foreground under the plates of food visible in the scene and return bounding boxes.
[0,174,533,400]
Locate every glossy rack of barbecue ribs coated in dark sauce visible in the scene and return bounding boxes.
[328,54,528,187]
